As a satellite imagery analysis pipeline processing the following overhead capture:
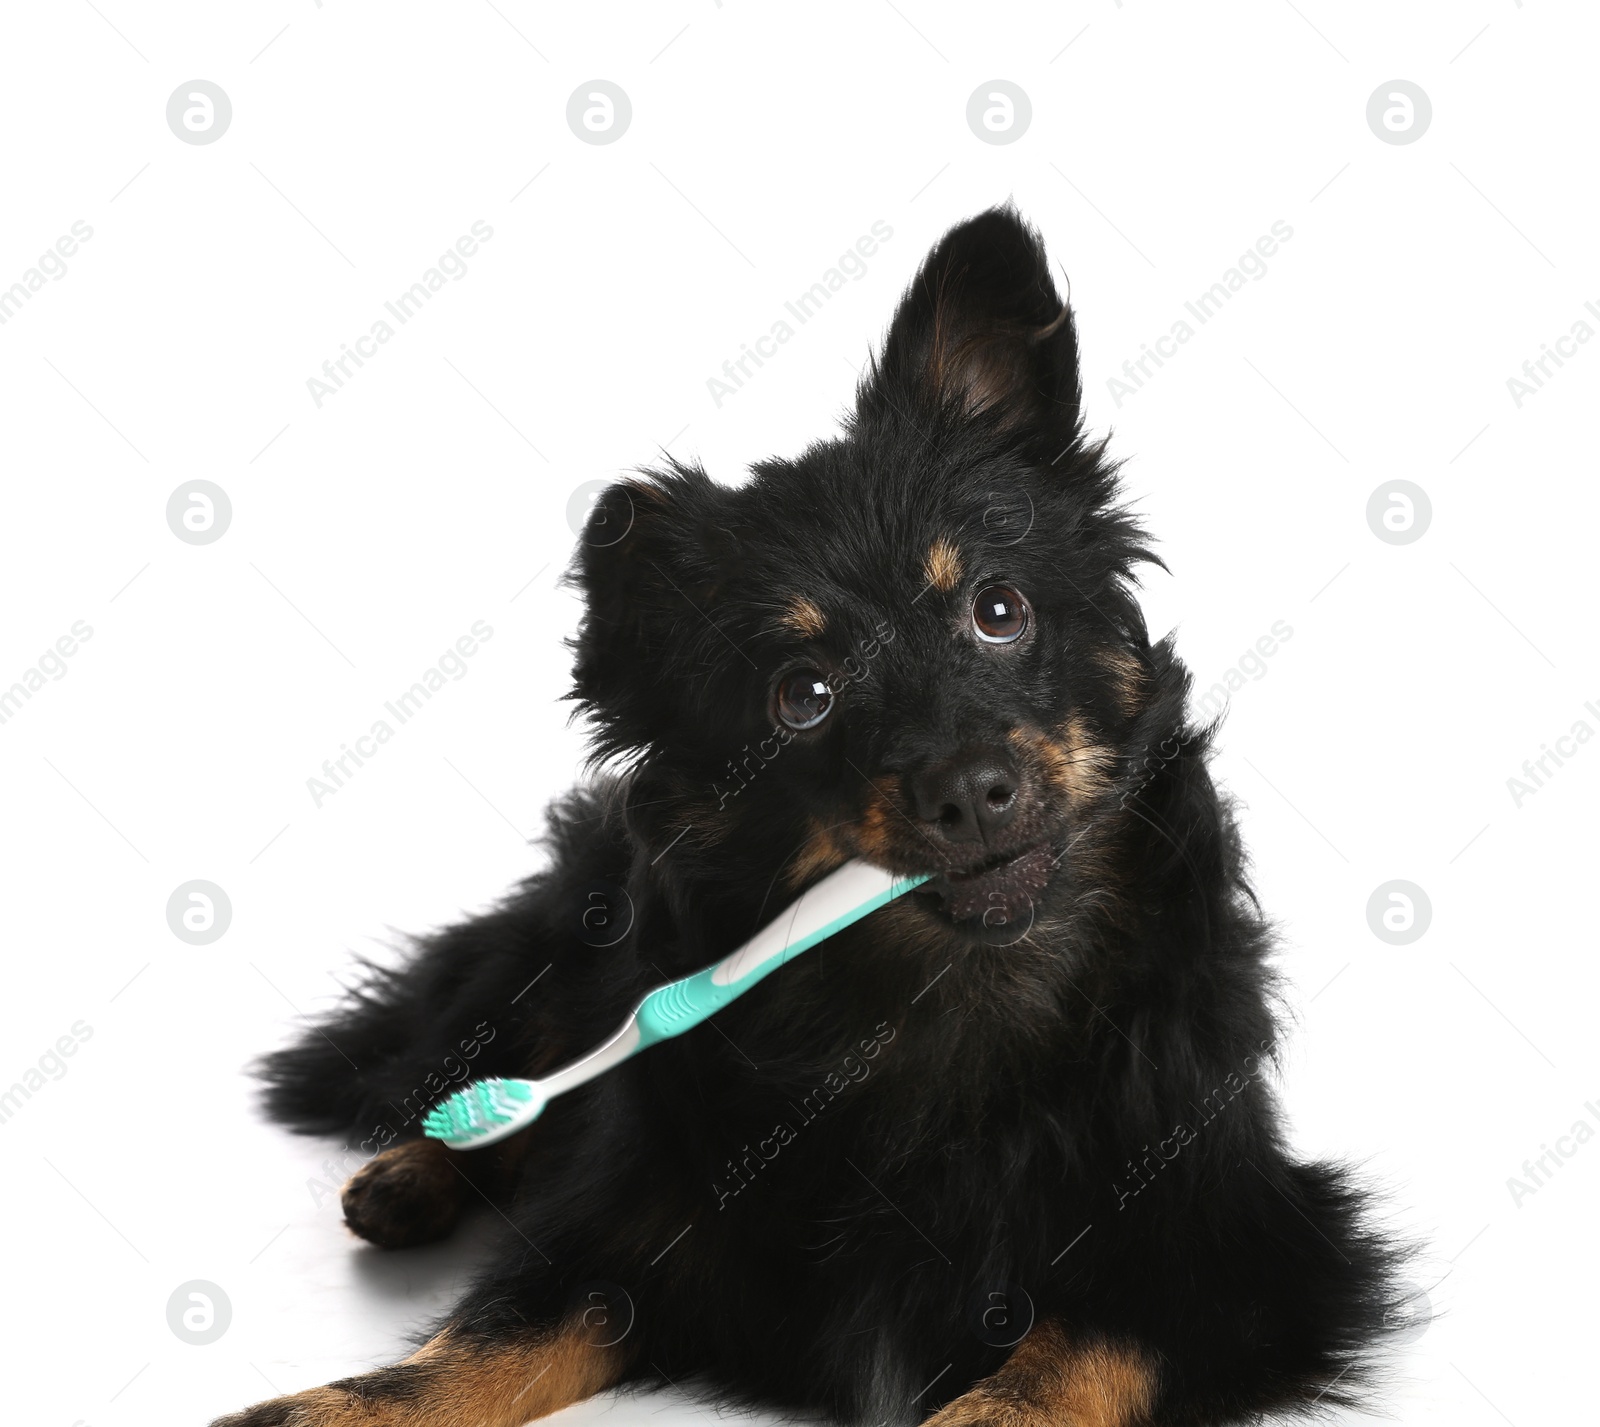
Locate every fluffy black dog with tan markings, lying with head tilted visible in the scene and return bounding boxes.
[222,210,1397,1427]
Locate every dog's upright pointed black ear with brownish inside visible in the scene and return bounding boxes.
[856,208,1082,435]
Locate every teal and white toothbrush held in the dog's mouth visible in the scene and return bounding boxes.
[422,862,928,1150]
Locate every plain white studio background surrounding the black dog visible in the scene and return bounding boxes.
[0,0,1600,1427]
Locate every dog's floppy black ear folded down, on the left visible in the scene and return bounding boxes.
[568,462,738,757]
